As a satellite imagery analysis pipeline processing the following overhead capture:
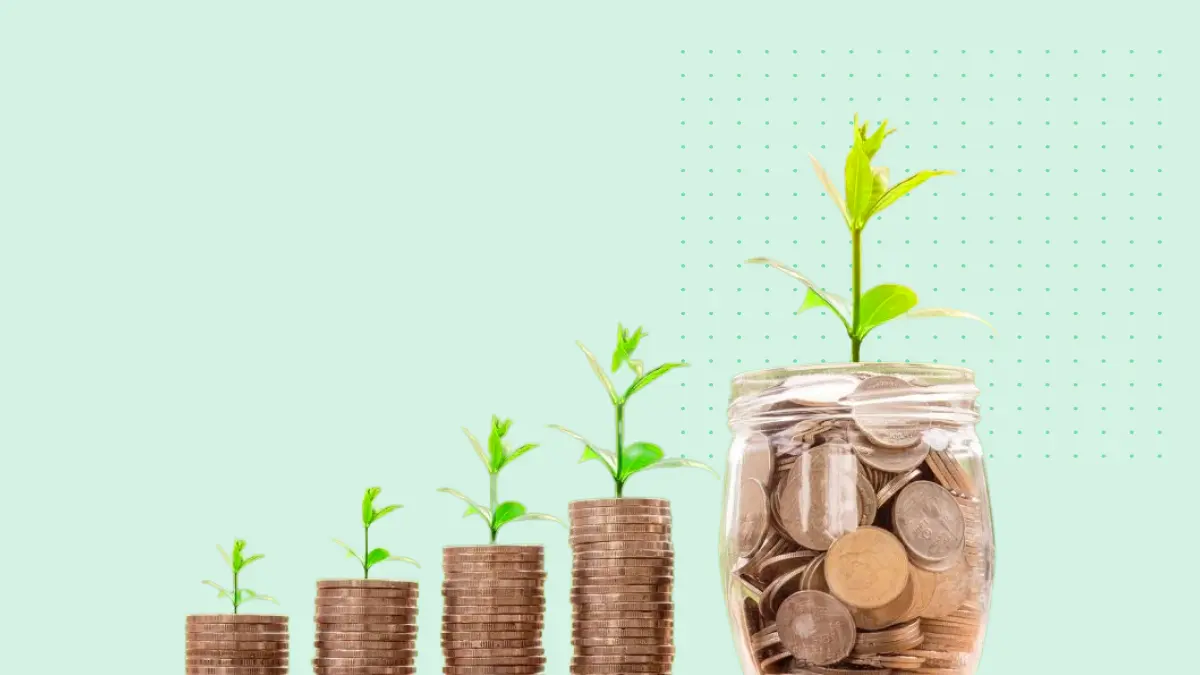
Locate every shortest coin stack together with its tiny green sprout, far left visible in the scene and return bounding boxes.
[186,539,288,675]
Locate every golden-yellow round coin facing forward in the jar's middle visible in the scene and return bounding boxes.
[824,527,908,609]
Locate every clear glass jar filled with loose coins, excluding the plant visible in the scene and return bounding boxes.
[720,363,995,675]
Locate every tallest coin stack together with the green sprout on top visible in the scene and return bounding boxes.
[554,324,715,675]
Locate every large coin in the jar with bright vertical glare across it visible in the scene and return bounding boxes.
[778,443,858,551]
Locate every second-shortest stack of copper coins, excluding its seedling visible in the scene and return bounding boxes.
[312,579,416,675]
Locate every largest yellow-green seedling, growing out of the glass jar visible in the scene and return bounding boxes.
[746,114,991,363]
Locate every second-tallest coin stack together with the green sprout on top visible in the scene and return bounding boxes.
[438,416,563,675]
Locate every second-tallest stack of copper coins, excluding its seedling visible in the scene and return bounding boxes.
[442,545,546,675]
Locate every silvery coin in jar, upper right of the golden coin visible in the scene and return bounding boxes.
[893,480,966,571]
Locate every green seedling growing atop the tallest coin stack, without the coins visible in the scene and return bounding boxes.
[551,323,716,497]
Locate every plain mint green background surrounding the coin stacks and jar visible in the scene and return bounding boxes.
[0,0,1196,674]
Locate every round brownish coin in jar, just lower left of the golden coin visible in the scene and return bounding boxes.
[775,591,856,665]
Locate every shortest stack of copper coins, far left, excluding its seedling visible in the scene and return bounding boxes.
[187,614,288,675]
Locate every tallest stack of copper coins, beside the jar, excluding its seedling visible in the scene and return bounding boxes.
[570,498,674,675]
